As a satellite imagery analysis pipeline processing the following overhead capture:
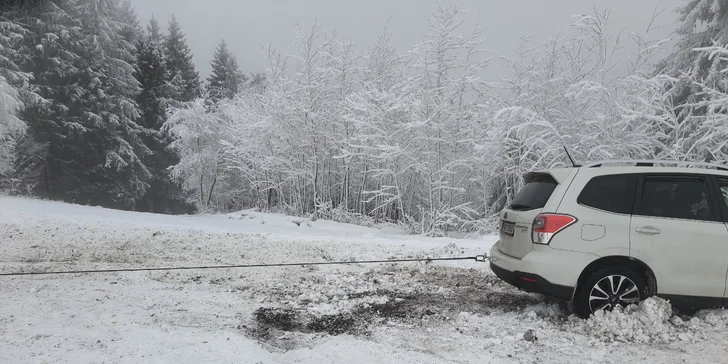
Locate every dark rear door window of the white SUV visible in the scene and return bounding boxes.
[637,175,715,221]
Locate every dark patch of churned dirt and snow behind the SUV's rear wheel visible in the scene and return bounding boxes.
[244,267,567,350]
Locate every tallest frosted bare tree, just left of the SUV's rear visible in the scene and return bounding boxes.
[404,4,490,234]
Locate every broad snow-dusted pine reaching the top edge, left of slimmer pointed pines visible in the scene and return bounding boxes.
[62,0,149,208]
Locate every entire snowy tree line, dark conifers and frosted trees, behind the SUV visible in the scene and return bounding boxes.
[0,0,728,235]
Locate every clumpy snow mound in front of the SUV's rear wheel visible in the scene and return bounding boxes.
[567,297,704,344]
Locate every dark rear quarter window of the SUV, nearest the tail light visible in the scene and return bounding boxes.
[576,173,638,214]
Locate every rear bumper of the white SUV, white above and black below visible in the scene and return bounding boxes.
[489,244,596,301]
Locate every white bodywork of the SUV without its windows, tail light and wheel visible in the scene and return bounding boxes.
[490,165,728,308]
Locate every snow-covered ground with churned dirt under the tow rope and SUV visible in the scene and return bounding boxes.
[0,197,728,364]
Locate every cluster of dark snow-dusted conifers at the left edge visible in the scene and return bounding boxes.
[0,0,249,213]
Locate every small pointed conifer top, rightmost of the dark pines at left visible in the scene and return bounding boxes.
[207,39,247,100]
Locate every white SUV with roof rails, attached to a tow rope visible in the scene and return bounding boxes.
[490,161,728,318]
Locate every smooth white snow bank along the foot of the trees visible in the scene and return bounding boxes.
[0,196,497,251]
